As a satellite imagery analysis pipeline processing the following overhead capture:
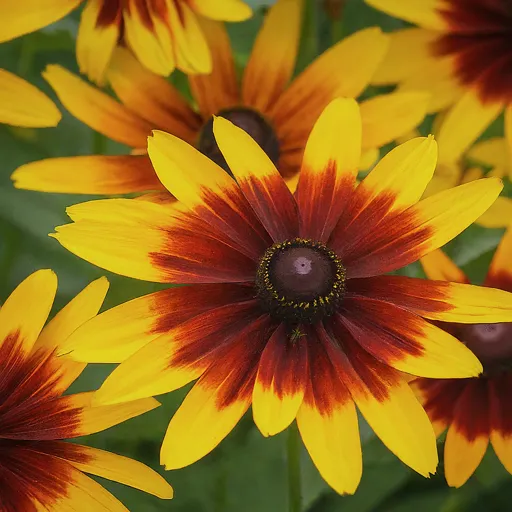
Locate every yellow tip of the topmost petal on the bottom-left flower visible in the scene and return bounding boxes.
[0,270,57,355]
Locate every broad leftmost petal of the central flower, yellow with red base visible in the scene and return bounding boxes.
[52,199,256,283]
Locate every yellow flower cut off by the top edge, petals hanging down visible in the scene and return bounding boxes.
[0,0,251,83]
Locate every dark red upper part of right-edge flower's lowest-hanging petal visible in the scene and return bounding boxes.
[452,378,490,442]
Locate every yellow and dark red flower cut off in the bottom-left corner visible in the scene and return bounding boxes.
[0,270,172,512]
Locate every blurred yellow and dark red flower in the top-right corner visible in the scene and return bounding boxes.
[366,0,512,161]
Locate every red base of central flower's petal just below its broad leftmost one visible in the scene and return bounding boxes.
[151,283,256,334]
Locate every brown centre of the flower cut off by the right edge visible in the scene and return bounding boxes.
[460,323,512,374]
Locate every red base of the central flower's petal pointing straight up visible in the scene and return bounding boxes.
[296,160,355,242]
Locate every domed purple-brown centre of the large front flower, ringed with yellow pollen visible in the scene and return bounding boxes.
[256,238,346,324]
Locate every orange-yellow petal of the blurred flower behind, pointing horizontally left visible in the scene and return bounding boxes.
[11,155,165,194]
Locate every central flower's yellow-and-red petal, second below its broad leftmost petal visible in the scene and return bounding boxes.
[95,301,261,404]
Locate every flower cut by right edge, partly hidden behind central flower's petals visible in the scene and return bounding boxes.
[413,228,512,487]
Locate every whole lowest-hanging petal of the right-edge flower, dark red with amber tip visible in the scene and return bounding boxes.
[444,379,490,487]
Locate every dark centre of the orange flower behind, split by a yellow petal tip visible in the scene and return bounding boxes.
[199,107,279,174]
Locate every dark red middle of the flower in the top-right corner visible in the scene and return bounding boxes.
[433,0,512,103]
